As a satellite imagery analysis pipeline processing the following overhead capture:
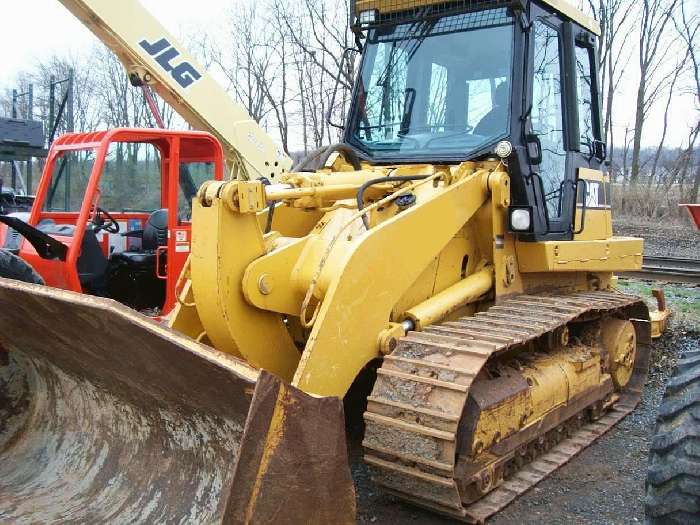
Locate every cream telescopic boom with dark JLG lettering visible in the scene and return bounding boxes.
[60,0,291,179]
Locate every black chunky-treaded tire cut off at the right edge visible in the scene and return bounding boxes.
[645,350,700,525]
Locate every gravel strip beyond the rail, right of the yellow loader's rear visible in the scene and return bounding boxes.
[613,219,700,259]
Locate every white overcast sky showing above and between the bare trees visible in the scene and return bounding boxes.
[0,0,697,146]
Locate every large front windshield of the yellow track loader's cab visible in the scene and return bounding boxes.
[349,8,513,159]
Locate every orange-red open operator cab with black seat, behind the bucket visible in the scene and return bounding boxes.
[20,129,223,315]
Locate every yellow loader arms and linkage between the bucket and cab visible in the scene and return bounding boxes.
[171,163,507,398]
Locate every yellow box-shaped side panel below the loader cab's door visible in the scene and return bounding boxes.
[516,237,643,273]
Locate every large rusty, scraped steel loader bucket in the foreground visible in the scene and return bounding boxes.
[0,279,355,523]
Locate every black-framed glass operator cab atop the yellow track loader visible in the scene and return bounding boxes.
[344,0,610,241]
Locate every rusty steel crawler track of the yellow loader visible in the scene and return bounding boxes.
[363,292,649,523]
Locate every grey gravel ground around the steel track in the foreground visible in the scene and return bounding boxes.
[351,327,700,525]
